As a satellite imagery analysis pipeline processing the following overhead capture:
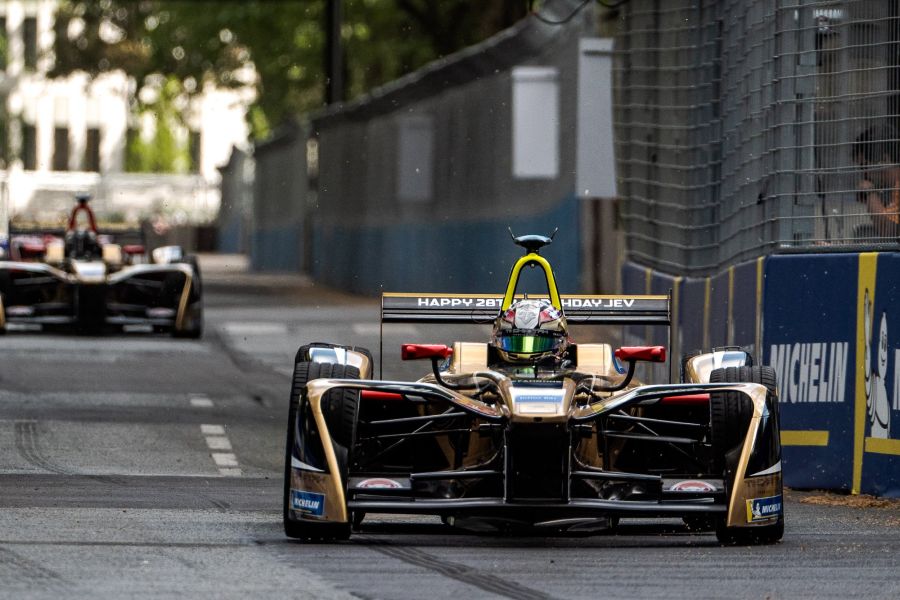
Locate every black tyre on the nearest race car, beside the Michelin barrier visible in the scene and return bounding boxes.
[709,367,784,545]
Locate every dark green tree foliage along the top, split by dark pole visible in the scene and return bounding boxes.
[51,0,527,137]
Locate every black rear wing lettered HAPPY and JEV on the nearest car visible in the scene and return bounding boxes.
[381,293,672,325]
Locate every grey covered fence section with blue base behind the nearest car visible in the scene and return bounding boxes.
[304,0,592,294]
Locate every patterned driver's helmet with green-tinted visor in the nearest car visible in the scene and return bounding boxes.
[491,299,569,362]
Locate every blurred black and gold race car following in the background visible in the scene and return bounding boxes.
[0,196,203,338]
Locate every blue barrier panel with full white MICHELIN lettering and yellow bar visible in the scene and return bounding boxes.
[763,254,859,490]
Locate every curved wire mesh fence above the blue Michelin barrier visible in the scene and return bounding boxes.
[615,0,900,274]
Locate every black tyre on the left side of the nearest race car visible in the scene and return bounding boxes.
[283,361,359,540]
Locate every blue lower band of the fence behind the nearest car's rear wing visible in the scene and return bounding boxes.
[312,196,581,295]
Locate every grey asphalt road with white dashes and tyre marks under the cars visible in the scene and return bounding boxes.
[0,264,900,600]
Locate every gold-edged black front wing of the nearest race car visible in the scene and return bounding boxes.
[290,379,782,527]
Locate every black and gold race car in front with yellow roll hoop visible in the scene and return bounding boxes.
[284,235,784,544]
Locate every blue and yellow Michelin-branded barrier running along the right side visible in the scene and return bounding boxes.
[622,252,900,497]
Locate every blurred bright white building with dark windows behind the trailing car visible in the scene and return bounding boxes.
[0,0,248,227]
